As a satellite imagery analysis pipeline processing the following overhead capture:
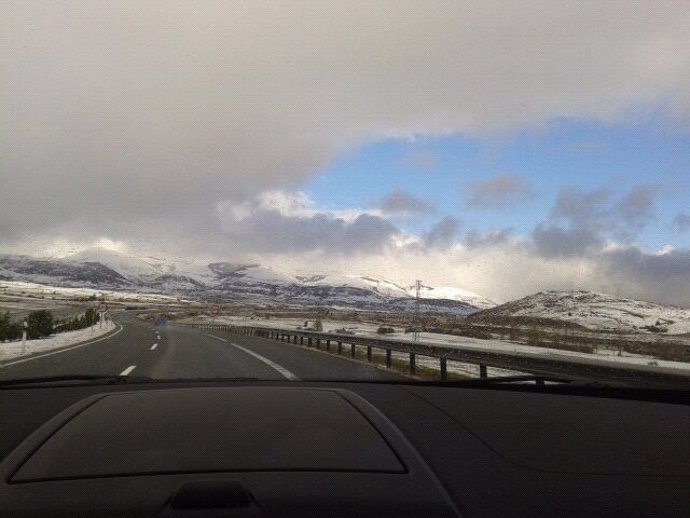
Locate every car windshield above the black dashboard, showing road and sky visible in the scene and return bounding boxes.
[0,0,690,386]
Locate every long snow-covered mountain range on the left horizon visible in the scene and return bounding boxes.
[0,249,494,315]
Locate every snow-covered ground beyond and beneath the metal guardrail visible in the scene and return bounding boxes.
[189,316,690,375]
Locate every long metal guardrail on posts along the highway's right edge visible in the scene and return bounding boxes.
[187,324,690,387]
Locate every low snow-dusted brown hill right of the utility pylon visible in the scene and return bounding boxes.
[472,291,690,334]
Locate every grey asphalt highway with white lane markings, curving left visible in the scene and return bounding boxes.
[0,313,401,380]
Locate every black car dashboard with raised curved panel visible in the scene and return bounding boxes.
[0,381,690,517]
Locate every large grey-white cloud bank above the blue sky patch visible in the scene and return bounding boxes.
[0,0,690,247]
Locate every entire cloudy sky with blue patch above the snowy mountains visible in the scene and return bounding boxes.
[0,0,690,305]
